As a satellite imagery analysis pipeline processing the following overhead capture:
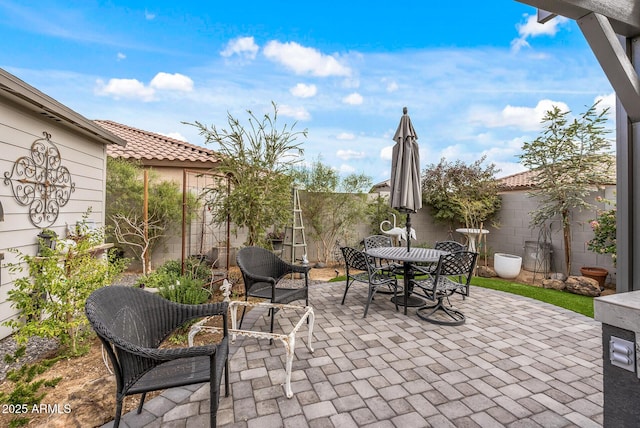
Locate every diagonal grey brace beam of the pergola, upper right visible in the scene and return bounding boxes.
[578,13,640,123]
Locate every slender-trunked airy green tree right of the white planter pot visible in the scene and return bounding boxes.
[520,103,614,274]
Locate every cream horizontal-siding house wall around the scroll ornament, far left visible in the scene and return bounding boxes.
[0,98,106,338]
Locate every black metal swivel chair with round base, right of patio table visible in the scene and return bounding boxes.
[411,251,478,325]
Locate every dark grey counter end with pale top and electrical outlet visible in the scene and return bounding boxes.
[593,291,640,428]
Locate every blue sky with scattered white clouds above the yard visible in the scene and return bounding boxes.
[0,0,614,183]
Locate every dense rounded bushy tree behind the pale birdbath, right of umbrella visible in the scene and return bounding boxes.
[422,156,502,228]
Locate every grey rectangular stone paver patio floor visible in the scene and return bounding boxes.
[105,282,603,428]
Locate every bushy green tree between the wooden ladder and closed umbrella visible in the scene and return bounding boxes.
[294,158,371,263]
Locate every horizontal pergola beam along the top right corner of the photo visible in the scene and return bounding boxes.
[517,0,640,37]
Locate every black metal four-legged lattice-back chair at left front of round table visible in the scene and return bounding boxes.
[340,247,398,318]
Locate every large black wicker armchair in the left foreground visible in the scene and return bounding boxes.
[85,286,229,427]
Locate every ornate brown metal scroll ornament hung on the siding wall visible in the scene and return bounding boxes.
[4,132,76,227]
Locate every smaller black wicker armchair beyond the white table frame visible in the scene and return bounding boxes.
[236,247,311,333]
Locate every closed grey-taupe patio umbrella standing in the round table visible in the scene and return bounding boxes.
[391,107,422,251]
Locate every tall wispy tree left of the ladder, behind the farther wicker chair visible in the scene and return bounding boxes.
[187,103,307,246]
